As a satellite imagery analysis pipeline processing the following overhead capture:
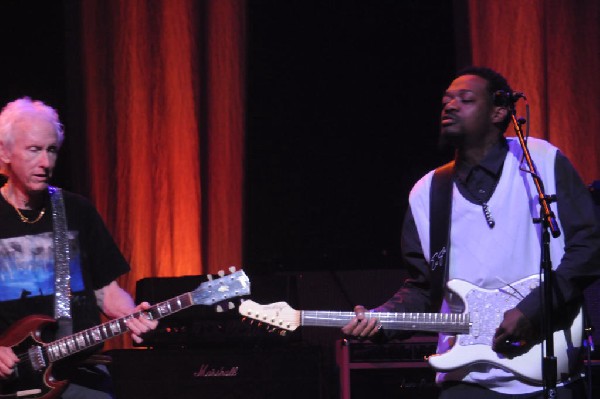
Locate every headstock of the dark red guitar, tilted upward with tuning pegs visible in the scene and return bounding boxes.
[191,267,250,305]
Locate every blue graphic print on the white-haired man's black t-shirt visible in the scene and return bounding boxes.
[0,231,84,302]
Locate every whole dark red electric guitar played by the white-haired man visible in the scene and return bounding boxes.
[0,268,250,399]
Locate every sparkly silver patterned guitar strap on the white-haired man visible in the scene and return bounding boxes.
[48,186,73,338]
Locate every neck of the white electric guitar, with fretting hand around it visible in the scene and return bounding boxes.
[299,310,470,333]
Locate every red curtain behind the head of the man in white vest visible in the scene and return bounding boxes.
[468,0,600,183]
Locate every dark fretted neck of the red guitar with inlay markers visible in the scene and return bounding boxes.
[44,292,194,362]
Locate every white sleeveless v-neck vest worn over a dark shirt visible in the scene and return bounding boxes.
[409,138,564,394]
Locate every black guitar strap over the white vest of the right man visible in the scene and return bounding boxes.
[429,161,454,309]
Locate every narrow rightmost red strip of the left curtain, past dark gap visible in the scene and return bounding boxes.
[205,0,245,271]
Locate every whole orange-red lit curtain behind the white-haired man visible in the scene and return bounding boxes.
[81,0,245,346]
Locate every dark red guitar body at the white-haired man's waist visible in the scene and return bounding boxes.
[0,315,68,399]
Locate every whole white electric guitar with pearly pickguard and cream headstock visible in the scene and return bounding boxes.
[238,276,583,384]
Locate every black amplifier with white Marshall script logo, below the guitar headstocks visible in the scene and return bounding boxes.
[108,345,322,399]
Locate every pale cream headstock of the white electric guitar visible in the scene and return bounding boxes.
[238,300,300,331]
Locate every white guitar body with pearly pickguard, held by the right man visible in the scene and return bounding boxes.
[429,277,583,384]
